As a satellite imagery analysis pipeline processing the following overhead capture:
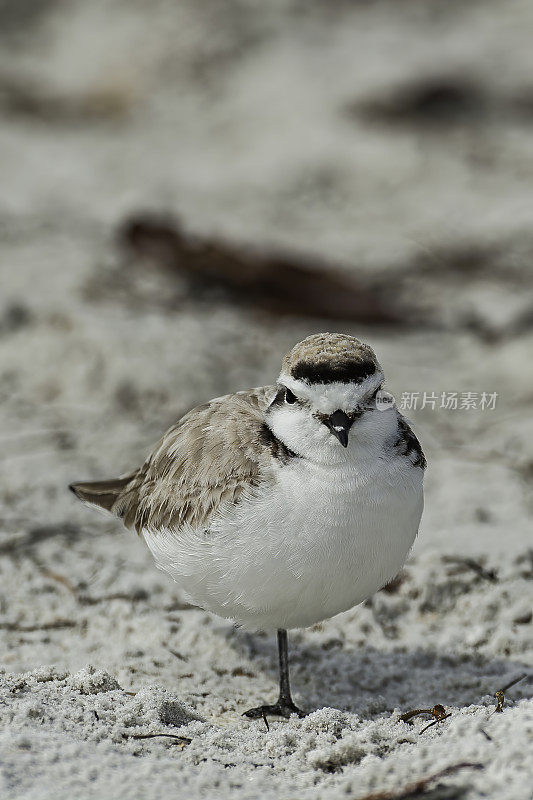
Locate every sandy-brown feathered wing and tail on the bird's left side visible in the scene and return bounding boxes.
[71,386,284,532]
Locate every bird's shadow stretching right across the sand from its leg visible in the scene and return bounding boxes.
[223,628,533,718]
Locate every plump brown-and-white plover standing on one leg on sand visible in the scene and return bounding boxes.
[69,333,426,721]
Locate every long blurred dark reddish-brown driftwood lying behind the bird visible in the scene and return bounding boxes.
[118,214,405,324]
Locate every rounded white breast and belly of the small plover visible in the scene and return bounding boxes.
[144,458,423,629]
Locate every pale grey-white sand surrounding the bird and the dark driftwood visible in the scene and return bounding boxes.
[0,0,533,800]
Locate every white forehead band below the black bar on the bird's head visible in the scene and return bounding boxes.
[278,370,384,414]
